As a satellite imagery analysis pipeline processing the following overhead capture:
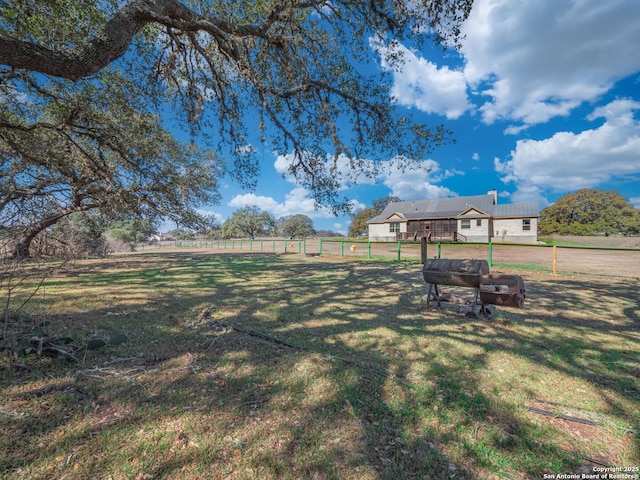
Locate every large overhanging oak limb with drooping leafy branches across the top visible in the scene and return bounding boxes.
[0,0,472,212]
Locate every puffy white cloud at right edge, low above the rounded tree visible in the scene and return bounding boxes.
[494,99,640,201]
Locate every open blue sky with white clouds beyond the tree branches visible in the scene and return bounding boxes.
[192,0,640,233]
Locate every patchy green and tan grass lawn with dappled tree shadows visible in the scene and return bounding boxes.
[0,252,640,479]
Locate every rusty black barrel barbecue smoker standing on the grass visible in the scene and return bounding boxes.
[422,238,526,318]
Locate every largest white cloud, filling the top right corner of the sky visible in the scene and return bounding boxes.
[461,0,640,125]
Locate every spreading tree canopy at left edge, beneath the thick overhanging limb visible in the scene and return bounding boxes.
[0,70,221,257]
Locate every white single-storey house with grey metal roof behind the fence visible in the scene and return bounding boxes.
[367,190,540,243]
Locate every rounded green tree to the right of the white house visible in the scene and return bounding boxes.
[539,188,640,235]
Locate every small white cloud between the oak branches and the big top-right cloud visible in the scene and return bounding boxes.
[371,39,471,119]
